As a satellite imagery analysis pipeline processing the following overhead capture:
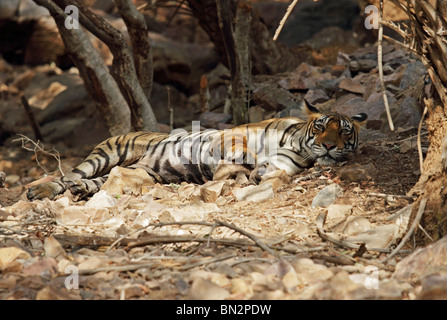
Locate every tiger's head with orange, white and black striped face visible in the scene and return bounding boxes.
[304,100,368,165]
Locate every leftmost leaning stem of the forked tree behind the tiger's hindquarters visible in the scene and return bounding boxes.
[35,0,131,135]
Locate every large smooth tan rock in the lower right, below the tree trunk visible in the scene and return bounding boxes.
[393,236,447,281]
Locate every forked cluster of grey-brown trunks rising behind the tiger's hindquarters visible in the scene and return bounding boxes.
[35,0,158,135]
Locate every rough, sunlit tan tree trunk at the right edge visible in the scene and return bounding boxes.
[387,0,447,244]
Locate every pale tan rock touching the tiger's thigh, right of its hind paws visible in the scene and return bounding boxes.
[101,167,155,196]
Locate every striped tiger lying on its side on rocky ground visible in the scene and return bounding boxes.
[27,101,368,200]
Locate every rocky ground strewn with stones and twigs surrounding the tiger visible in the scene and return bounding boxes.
[0,0,447,300]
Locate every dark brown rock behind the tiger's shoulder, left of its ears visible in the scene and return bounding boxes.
[252,85,296,111]
